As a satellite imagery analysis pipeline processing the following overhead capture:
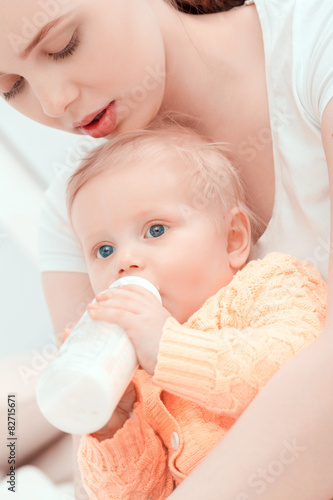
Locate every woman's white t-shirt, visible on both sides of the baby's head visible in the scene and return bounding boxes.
[40,0,333,279]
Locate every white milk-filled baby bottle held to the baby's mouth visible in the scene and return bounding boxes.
[37,276,161,434]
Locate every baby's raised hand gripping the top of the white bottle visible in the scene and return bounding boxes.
[88,285,170,375]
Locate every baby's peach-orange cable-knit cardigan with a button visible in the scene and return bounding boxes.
[78,253,326,500]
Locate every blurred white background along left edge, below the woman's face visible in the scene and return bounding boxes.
[0,100,82,357]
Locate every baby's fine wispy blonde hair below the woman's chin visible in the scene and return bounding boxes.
[67,119,255,236]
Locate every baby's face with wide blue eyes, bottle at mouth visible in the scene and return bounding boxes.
[71,161,234,323]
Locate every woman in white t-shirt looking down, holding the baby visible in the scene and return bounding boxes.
[0,0,333,500]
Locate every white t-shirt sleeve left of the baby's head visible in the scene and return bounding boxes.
[38,177,87,273]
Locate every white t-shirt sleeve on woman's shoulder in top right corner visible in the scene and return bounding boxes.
[295,0,333,124]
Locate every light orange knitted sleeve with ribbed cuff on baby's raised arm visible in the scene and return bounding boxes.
[153,254,326,418]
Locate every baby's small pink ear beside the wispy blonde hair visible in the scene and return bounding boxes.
[226,207,251,270]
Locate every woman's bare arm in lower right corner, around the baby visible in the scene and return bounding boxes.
[168,101,333,500]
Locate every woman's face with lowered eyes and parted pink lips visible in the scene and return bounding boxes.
[0,0,165,137]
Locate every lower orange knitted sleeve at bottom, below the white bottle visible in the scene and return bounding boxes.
[78,382,173,500]
